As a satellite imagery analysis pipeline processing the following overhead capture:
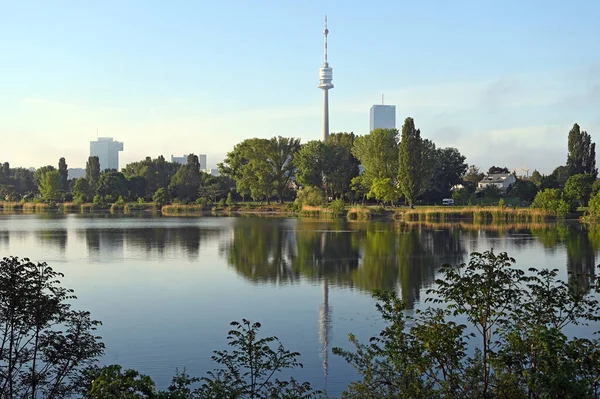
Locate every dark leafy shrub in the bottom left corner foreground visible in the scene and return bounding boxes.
[0,258,104,399]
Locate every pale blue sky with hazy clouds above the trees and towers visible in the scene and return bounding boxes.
[0,0,600,173]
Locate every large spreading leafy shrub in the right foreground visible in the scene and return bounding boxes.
[333,251,600,399]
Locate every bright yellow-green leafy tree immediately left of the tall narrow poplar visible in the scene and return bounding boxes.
[352,129,398,192]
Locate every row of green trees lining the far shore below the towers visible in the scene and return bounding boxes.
[0,118,600,211]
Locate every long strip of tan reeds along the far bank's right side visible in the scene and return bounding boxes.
[394,206,556,223]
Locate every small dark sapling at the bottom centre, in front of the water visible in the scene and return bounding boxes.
[199,319,315,399]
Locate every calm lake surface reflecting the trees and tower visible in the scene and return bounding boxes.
[0,215,600,396]
